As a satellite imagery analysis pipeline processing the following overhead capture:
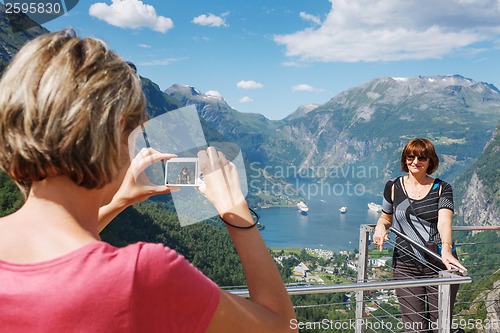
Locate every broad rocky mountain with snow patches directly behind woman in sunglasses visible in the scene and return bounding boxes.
[275,75,500,174]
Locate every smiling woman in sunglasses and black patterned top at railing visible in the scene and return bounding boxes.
[373,138,466,332]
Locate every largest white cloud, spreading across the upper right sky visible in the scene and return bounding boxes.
[274,0,500,62]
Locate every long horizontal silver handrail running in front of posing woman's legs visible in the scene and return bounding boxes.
[229,270,472,297]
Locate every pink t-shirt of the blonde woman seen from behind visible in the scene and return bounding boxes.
[0,242,219,333]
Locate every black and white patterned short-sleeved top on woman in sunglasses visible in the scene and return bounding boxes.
[382,177,454,264]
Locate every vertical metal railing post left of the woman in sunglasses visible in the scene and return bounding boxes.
[356,224,373,333]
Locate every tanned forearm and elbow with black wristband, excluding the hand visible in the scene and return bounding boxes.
[207,204,295,333]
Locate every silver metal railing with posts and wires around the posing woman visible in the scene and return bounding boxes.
[230,225,500,333]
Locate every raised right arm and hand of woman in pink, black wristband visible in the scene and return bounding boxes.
[198,147,296,333]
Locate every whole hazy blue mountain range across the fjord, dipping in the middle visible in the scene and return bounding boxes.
[166,75,500,193]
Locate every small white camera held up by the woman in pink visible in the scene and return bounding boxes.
[165,157,203,186]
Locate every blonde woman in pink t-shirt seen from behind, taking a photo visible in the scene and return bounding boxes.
[0,30,294,333]
